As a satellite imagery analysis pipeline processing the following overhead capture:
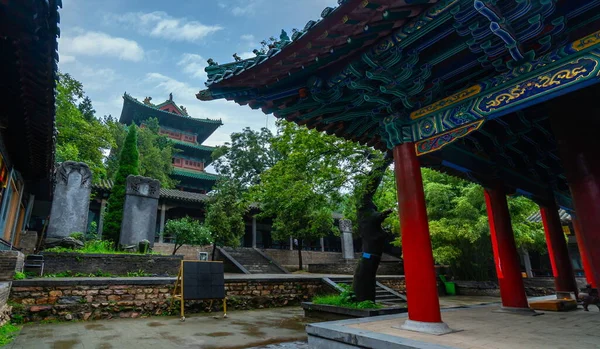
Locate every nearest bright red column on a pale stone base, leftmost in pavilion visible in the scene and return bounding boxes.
[394,143,449,333]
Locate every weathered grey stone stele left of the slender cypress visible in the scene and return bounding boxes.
[47,161,92,239]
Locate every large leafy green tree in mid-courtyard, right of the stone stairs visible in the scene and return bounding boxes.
[251,121,373,268]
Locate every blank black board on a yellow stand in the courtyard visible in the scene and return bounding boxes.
[169,260,227,321]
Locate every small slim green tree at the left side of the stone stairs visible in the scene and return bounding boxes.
[204,179,247,260]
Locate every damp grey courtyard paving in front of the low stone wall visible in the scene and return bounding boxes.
[6,307,316,349]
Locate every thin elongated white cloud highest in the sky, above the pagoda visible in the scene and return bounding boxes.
[106,11,223,42]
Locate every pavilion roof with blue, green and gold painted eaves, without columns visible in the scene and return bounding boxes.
[197,0,600,206]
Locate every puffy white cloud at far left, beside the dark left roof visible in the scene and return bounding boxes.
[59,31,144,62]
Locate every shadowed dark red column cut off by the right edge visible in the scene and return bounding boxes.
[551,113,600,286]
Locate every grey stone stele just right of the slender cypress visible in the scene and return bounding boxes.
[119,176,160,248]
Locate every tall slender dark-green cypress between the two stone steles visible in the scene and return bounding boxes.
[102,125,140,244]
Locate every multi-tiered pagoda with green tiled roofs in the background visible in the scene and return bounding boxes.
[89,93,222,242]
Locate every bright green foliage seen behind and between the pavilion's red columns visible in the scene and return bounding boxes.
[380,168,545,280]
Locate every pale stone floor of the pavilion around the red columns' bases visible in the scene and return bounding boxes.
[344,297,600,349]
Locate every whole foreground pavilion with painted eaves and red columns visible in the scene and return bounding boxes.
[196,0,600,338]
